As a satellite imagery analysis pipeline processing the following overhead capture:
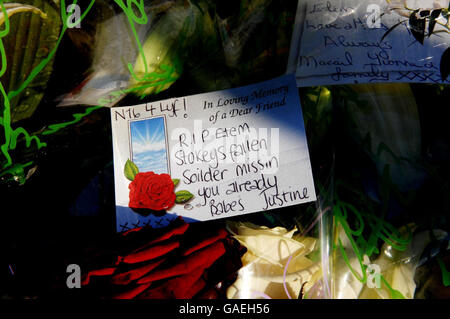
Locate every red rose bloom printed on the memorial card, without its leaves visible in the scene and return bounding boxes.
[128,172,176,211]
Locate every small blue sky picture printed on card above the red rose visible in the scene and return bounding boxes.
[130,117,169,174]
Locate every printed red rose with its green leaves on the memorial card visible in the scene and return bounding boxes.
[124,160,194,215]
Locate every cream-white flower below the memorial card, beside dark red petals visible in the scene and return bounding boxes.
[227,222,320,299]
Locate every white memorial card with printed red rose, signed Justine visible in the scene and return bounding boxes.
[111,75,316,232]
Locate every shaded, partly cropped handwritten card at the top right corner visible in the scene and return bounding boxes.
[288,0,450,86]
